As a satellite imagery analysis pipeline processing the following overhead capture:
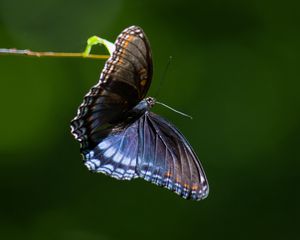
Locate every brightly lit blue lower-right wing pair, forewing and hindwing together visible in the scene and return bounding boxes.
[83,111,209,200]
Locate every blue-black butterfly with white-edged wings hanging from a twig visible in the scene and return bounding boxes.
[71,26,209,200]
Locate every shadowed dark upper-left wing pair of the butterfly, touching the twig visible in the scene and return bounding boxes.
[71,26,152,152]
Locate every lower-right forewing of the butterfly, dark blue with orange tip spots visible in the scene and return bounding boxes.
[137,112,209,200]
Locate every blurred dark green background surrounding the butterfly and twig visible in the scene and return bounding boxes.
[0,0,300,240]
